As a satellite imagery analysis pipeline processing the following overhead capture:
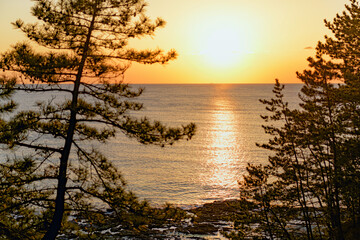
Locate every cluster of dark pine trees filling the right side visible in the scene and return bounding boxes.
[232,0,360,240]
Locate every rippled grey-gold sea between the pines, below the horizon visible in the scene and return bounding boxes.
[7,84,302,208]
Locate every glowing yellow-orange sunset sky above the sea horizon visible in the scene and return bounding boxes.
[0,0,349,84]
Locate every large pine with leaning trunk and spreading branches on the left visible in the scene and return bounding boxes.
[0,0,195,239]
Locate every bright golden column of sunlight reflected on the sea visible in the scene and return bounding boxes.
[203,92,243,199]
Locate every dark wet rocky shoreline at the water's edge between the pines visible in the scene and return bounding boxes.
[58,199,240,240]
